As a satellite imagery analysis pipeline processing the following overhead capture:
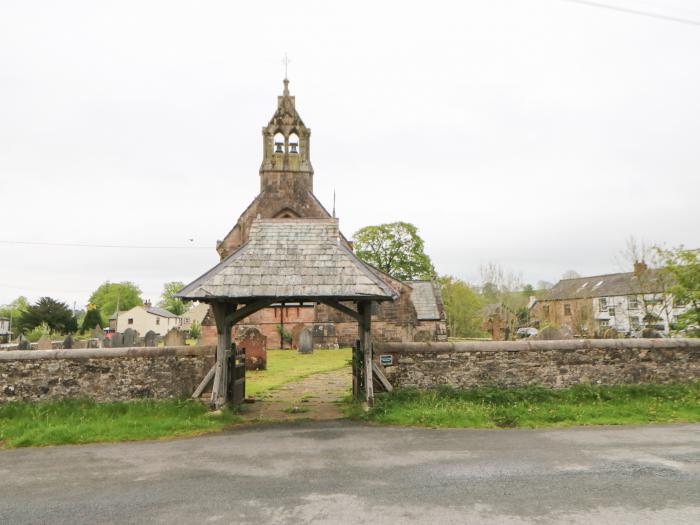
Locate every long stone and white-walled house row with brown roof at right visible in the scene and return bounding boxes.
[530,263,688,336]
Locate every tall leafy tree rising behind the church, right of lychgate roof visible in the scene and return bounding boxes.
[354,222,435,281]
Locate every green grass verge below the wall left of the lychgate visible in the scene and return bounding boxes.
[0,399,242,448]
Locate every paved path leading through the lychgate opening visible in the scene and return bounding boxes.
[242,367,352,421]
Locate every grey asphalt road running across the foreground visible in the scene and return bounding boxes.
[0,421,700,524]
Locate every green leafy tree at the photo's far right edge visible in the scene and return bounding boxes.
[655,245,700,334]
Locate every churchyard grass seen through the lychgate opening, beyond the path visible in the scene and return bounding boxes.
[246,348,352,397]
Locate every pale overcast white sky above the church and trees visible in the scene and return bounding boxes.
[0,0,700,307]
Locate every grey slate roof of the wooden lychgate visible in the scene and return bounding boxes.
[177,218,399,302]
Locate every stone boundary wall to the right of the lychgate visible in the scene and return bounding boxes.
[374,339,700,388]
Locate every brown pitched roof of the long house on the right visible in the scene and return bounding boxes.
[543,269,665,301]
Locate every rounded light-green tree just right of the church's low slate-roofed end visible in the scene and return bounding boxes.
[438,275,483,337]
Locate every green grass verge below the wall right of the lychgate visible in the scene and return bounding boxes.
[347,382,700,428]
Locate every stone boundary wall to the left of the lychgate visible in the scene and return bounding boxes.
[0,346,216,402]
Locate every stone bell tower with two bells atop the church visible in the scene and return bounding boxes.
[260,78,314,193]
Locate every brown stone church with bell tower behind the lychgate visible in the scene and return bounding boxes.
[202,78,447,348]
